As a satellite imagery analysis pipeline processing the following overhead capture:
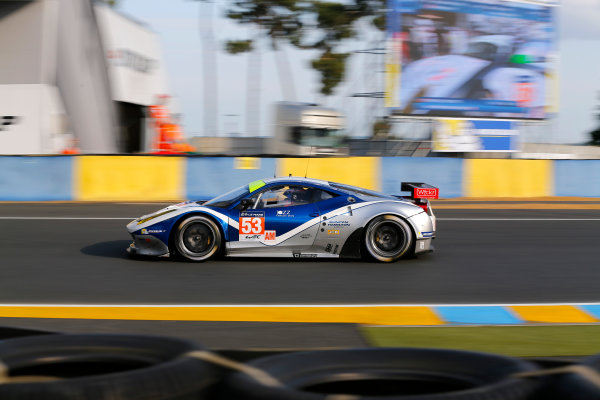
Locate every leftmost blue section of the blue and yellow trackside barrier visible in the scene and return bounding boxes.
[0,156,73,201]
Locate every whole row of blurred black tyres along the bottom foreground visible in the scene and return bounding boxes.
[0,328,600,400]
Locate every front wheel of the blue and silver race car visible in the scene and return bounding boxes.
[173,215,223,262]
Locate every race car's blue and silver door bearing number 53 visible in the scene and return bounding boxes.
[228,184,326,257]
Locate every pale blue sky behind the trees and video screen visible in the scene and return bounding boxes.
[117,0,600,143]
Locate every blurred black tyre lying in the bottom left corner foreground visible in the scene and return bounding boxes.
[0,334,221,400]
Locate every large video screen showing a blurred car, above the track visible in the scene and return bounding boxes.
[386,0,556,119]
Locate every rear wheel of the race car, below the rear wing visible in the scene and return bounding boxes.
[363,215,415,262]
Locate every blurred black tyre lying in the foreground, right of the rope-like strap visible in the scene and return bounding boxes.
[221,348,538,400]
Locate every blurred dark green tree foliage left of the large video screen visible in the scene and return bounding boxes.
[221,0,385,95]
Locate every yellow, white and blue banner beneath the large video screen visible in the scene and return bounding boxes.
[432,118,518,152]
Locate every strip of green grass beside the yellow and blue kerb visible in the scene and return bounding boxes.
[360,325,600,357]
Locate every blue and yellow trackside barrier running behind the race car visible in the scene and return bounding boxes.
[0,155,600,201]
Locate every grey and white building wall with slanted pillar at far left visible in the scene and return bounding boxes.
[0,0,119,154]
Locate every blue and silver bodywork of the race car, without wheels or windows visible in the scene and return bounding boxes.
[127,177,435,258]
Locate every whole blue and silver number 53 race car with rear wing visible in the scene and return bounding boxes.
[127,177,439,262]
